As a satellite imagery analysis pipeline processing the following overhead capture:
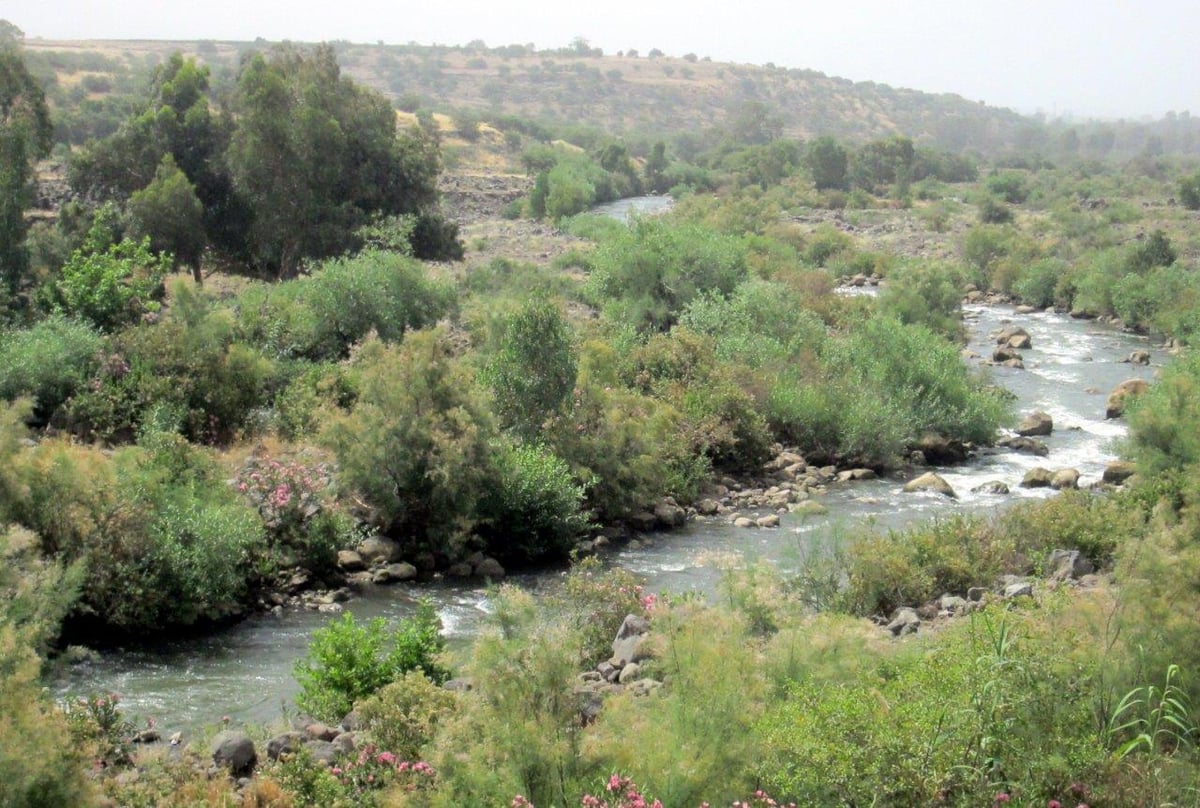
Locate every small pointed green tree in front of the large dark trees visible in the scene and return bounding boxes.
[130,154,205,283]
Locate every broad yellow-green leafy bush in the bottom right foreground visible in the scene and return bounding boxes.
[757,611,1108,806]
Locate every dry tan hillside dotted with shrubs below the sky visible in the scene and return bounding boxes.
[25,40,1040,152]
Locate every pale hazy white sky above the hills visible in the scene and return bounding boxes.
[0,0,1200,118]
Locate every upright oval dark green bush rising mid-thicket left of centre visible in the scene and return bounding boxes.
[482,292,576,439]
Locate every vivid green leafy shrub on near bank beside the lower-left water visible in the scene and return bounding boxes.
[295,601,449,722]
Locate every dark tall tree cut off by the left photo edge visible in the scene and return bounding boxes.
[0,37,53,303]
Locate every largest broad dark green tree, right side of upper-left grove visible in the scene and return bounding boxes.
[229,46,454,275]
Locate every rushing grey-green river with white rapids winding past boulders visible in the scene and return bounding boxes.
[55,226,1168,734]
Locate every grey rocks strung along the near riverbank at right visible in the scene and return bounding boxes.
[877,550,1100,638]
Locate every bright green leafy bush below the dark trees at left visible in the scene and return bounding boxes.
[54,216,170,331]
